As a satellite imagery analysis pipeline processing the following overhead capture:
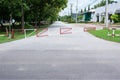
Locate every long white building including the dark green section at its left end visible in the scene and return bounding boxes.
[82,1,120,22]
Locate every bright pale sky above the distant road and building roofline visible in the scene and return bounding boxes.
[59,0,118,16]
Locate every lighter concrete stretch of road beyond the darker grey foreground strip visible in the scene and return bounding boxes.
[0,22,120,50]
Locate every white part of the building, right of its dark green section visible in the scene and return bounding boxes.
[91,1,120,22]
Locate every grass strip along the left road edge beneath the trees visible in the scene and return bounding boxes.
[0,25,49,43]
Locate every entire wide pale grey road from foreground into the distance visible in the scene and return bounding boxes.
[0,22,120,80]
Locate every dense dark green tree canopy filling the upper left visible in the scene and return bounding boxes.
[0,0,68,21]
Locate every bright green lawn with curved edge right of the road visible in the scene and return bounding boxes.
[89,30,120,43]
